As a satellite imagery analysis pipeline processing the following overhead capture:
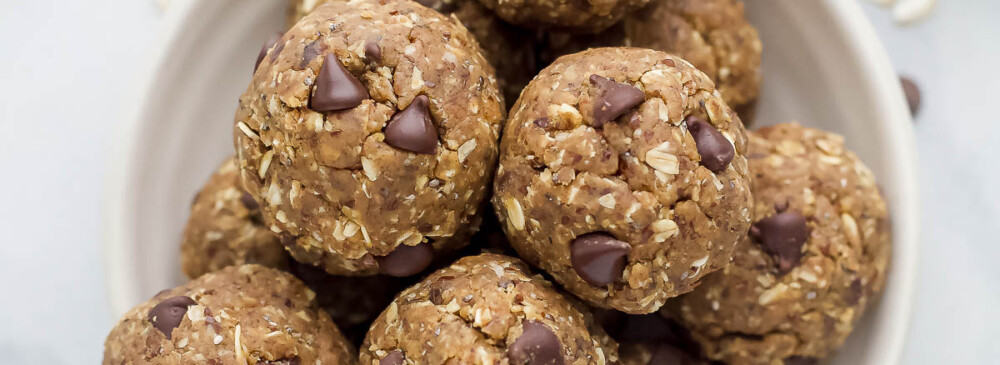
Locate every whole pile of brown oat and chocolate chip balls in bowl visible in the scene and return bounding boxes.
[104,0,891,365]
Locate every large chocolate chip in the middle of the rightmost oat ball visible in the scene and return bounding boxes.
[750,211,809,273]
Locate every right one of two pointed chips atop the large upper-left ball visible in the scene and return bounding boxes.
[385,95,438,154]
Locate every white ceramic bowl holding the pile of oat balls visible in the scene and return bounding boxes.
[106,0,918,365]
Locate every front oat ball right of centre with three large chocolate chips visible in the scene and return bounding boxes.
[493,48,750,314]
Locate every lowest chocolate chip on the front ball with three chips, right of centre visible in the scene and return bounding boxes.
[570,232,632,286]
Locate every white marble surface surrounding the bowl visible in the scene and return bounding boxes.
[0,0,1000,364]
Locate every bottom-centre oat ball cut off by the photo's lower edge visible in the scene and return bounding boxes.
[361,254,618,365]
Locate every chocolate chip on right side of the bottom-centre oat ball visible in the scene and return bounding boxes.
[507,321,563,365]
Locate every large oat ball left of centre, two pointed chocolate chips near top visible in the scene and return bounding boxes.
[234,0,504,276]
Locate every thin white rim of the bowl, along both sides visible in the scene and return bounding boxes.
[103,0,920,364]
